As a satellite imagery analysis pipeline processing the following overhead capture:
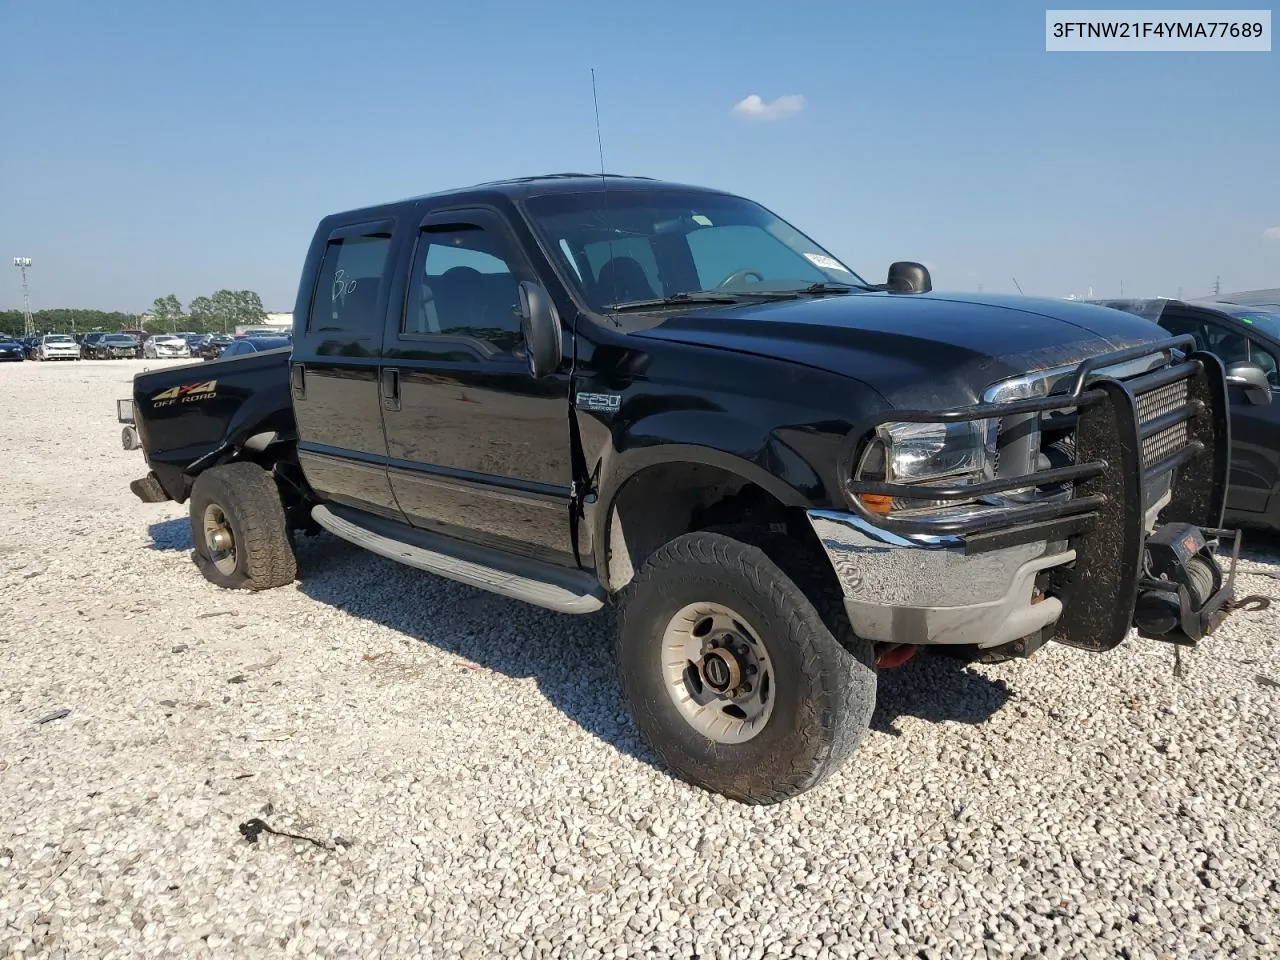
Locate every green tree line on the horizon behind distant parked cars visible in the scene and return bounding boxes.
[0,291,266,337]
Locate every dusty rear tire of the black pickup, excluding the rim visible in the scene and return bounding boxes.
[189,462,297,590]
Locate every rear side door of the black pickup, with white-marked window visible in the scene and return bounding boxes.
[289,219,403,520]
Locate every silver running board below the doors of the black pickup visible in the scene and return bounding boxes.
[311,506,604,613]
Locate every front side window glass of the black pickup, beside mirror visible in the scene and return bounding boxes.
[401,224,521,356]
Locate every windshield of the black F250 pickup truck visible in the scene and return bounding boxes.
[525,189,865,310]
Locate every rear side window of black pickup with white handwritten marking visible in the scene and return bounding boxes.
[307,233,392,333]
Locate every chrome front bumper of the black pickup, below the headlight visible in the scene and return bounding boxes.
[808,509,1075,648]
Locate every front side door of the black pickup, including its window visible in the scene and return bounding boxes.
[381,207,573,566]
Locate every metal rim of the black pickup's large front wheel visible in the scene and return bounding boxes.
[662,603,777,744]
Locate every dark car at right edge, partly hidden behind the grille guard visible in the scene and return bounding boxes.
[1098,300,1280,531]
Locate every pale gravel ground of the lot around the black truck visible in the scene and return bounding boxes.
[0,361,1280,959]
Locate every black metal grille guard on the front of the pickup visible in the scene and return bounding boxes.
[844,335,1230,553]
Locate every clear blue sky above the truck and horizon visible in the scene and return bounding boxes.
[0,0,1280,310]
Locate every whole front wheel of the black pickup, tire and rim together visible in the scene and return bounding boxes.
[617,531,876,804]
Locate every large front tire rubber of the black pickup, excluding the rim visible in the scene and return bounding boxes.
[616,531,876,804]
